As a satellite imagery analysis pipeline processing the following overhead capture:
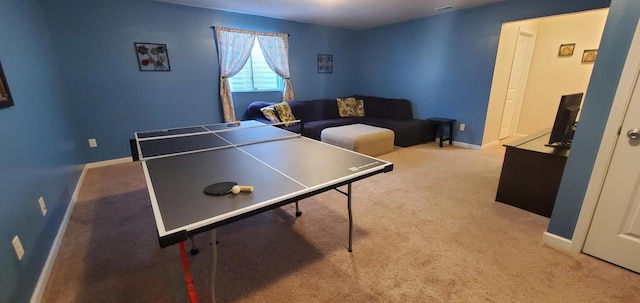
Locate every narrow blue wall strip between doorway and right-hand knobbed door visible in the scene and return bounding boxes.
[548,0,640,239]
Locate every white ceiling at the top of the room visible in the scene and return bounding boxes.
[156,0,506,30]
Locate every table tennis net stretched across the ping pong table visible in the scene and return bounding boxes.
[132,121,301,161]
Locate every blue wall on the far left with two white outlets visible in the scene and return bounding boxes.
[0,0,81,302]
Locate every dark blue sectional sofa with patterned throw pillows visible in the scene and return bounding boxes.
[246,95,429,147]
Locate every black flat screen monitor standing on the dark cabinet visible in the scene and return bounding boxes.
[547,93,584,148]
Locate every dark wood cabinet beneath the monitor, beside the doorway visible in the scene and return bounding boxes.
[496,129,569,217]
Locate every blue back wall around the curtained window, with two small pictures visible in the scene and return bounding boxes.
[42,0,357,162]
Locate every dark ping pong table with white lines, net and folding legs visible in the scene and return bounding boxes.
[132,121,393,301]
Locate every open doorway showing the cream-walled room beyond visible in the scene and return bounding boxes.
[482,9,608,148]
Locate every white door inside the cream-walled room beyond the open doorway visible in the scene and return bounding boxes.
[498,29,535,139]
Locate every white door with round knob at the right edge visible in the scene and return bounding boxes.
[583,70,640,272]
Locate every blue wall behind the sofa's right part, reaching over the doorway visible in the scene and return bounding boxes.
[358,0,610,145]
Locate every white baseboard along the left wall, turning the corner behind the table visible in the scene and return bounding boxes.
[30,157,132,303]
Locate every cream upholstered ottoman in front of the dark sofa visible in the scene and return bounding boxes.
[320,124,395,156]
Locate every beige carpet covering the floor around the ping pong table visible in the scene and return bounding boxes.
[43,143,640,303]
